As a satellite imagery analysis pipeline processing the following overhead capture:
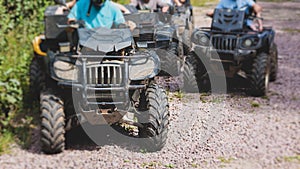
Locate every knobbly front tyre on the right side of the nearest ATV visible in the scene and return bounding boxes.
[139,84,170,152]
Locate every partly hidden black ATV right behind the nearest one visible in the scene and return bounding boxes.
[125,5,189,76]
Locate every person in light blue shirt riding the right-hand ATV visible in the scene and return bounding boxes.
[206,0,263,31]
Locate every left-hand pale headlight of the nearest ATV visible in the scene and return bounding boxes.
[53,60,78,81]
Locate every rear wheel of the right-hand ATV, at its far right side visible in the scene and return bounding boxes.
[270,43,278,82]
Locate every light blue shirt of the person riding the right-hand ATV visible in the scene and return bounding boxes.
[216,0,255,26]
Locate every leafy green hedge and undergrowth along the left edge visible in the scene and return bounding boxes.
[0,0,53,153]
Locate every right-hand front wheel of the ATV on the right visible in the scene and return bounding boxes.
[249,53,270,96]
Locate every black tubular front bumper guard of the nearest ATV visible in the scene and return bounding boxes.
[58,53,150,107]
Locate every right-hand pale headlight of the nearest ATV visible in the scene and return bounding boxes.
[129,51,160,80]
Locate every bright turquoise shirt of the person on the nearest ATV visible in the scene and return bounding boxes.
[68,0,125,29]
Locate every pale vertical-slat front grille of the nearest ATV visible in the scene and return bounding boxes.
[86,64,123,87]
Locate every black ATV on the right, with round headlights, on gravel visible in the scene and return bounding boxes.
[185,9,278,96]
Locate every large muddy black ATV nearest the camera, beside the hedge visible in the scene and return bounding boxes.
[30,3,169,154]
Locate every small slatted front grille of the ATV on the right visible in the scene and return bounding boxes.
[212,35,237,51]
